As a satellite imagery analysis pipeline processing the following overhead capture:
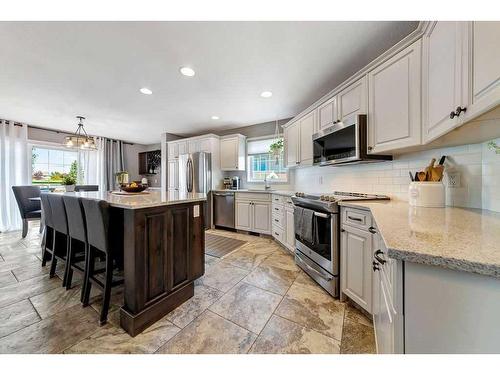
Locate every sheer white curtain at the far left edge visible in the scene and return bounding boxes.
[0,120,30,232]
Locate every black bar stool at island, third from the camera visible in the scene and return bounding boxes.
[48,194,69,286]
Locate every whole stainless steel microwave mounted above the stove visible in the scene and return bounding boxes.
[312,115,392,166]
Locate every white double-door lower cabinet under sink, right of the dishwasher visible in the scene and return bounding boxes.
[235,193,271,234]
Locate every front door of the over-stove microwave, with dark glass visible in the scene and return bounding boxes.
[313,117,360,166]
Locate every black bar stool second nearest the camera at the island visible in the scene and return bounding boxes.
[62,195,87,302]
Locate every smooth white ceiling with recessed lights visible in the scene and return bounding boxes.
[0,22,417,144]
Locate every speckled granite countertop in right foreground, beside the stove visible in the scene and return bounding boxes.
[341,201,500,278]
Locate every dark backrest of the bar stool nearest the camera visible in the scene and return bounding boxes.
[81,198,110,254]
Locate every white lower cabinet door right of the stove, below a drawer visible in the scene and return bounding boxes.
[340,225,373,313]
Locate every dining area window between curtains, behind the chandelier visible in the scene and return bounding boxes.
[31,146,78,185]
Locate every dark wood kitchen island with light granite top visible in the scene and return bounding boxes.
[67,191,207,336]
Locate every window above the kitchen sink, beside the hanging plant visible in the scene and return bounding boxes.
[247,138,288,182]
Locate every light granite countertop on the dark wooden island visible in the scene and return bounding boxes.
[49,190,207,209]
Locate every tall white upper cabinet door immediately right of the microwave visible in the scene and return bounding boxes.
[368,40,421,153]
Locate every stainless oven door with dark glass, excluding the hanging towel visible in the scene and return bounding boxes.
[295,211,339,276]
